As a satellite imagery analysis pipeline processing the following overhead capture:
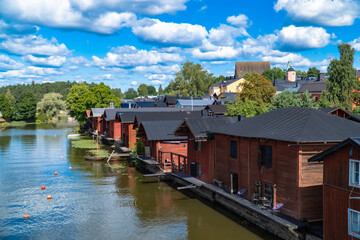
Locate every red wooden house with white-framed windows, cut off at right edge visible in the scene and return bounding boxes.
[309,138,360,240]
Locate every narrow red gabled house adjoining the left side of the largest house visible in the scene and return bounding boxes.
[175,117,236,183]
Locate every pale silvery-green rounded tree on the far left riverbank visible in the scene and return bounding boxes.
[36,93,66,117]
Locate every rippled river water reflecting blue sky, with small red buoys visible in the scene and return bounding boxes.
[0,125,274,240]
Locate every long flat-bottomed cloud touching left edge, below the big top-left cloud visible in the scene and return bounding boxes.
[0,35,70,56]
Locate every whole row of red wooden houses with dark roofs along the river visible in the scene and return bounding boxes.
[88,107,360,239]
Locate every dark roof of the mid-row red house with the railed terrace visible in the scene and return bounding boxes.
[138,120,187,141]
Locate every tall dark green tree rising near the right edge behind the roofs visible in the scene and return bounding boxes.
[322,43,359,110]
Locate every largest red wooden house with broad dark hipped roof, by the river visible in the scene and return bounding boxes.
[214,108,360,221]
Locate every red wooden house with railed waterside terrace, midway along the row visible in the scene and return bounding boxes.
[137,120,187,172]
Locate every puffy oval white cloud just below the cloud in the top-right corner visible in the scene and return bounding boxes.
[277,25,331,51]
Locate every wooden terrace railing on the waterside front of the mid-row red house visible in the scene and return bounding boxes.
[158,150,187,173]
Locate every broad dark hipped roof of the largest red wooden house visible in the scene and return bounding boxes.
[215,107,360,143]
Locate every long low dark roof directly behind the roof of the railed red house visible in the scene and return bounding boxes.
[134,111,201,128]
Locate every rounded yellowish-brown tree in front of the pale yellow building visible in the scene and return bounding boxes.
[240,73,276,108]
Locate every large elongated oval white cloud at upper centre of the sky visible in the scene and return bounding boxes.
[132,18,208,46]
